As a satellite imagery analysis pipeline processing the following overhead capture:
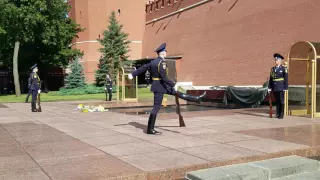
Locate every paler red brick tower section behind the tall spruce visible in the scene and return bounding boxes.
[70,0,145,83]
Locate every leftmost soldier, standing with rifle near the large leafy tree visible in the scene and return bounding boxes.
[30,64,41,112]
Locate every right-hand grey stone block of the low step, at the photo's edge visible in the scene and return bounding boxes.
[249,156,320,179]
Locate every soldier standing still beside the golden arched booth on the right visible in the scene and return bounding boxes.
[268,53,288,119]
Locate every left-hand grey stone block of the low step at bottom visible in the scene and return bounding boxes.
[186,164,269,180]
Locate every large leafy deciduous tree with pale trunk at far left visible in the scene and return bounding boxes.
[0,0,82,96]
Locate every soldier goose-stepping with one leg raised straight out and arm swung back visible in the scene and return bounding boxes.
[128,43,205,135]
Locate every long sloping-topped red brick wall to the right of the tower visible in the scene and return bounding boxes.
[143,0,320,85]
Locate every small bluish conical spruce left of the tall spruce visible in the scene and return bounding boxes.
[64,58,86,89]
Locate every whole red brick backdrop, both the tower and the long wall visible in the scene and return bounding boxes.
[70,0,320,86]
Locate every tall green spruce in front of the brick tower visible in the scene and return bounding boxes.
[95,11,130,86]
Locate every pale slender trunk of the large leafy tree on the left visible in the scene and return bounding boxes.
[13,41,21,96]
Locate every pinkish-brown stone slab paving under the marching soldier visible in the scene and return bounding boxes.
[0,102,320,180]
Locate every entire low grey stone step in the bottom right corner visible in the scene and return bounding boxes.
[186,156,320,180]
